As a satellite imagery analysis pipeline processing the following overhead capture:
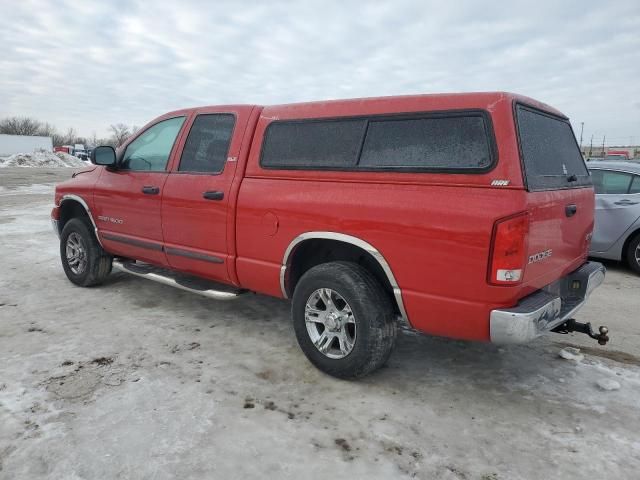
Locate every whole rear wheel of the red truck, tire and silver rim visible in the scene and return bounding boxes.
[291,262,396,378]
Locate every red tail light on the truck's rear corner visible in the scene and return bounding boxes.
[488,212,529,285]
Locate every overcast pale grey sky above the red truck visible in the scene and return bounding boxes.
[0,0,640,144]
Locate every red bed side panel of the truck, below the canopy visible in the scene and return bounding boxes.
[236,178,522,340]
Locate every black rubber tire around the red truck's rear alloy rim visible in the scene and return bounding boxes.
[291,262,397,379]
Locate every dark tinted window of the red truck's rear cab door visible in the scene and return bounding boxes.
[178,113,235,173]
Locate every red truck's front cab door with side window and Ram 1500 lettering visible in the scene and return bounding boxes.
[94,115,186,264]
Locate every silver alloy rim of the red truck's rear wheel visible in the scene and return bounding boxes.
[304,288,356,359]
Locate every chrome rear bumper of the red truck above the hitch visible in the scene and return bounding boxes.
[490,262,606,343]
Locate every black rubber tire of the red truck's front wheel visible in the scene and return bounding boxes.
[60,218,113,287]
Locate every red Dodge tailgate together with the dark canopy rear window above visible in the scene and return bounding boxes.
[516,104,595,288]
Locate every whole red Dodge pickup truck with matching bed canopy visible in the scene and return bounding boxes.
[52,93,608,378]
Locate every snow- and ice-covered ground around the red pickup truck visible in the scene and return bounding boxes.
[0,168,640,480]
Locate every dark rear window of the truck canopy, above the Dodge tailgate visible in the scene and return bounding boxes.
[516,105,591,191]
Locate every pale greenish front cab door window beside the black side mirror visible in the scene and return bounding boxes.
[120,117,184,172]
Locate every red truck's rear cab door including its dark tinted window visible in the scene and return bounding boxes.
[162,106,252,282]
